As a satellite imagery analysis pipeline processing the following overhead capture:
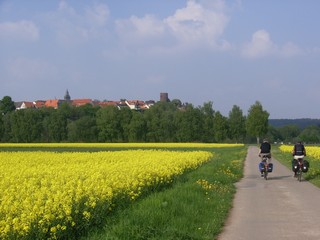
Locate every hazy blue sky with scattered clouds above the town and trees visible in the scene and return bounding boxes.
[0,0,320,118]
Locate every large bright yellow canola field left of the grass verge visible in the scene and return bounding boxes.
[0,150,213,239]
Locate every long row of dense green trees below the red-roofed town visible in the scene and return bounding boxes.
[0,96,320,143]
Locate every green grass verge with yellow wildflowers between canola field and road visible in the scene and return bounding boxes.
[82,147,247,240]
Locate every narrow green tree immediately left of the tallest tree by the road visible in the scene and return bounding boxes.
[228,105,246,142]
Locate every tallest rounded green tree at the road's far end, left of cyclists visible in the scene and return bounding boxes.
[246,101,269,144]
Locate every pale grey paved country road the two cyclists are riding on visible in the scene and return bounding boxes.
[218,146,320,240]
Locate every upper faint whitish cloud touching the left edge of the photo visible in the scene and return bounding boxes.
[0,20,39,41]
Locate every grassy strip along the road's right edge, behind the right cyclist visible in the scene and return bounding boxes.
[272,146,320,187]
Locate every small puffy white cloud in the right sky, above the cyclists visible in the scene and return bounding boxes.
[242,29,303,58]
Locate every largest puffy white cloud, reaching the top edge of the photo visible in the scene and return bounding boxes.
[116,0,229,49]
